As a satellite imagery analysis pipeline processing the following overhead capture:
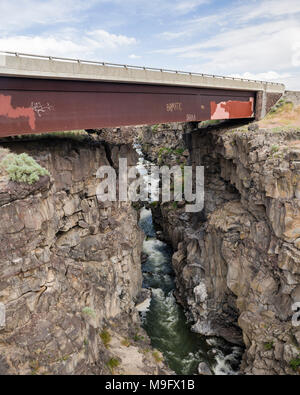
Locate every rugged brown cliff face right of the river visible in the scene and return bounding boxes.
[141,125,300,374]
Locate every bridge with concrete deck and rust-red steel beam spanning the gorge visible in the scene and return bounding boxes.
[0,52,285,137]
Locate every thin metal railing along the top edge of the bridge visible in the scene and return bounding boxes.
[0,51,283,85]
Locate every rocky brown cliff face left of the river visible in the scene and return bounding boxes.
[0,139,169,374]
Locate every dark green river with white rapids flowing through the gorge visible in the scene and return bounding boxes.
[140,209,241,375]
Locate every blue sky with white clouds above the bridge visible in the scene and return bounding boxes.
[0,0,300,90]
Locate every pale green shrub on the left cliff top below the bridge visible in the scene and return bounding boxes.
[0,153,50,185]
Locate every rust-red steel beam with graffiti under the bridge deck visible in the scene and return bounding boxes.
[0,77,256,137]
